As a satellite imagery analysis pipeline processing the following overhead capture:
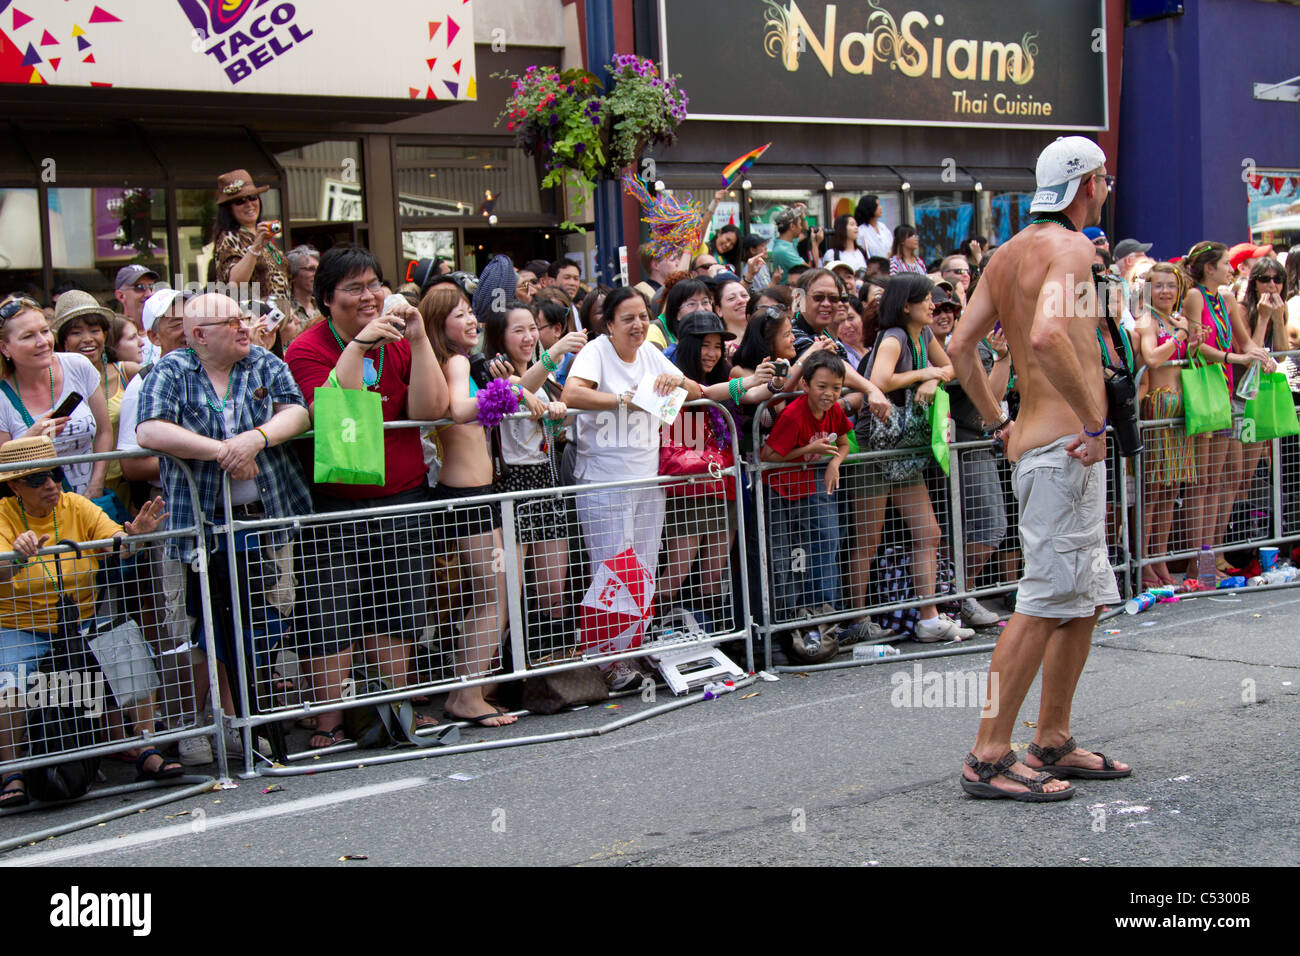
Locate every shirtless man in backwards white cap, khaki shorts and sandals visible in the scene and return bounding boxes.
[948,137,1131,803]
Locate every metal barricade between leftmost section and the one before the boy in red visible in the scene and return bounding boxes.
[216,401,754,777]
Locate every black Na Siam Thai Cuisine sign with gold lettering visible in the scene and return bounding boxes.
[659,0,1108,130]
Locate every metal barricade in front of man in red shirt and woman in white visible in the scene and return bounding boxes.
[217,401,754,775]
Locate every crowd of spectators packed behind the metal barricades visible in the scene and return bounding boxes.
[0,170,1300,785]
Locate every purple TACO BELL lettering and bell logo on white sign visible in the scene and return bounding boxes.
[177,0,313,86]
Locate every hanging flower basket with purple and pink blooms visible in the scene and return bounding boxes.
[494,55,689,229]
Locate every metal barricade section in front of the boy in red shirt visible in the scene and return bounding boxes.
[748,393,1134,672]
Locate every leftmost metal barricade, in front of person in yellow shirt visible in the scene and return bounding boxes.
[0,451,226,851]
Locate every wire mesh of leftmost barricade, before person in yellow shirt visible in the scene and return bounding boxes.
[0,530,212,770]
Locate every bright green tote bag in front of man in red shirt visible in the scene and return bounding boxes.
[315,372,385,485]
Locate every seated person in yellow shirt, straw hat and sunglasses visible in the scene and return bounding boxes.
[0,436,167,808]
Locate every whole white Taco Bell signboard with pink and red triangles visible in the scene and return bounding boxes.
[0,0,478,101]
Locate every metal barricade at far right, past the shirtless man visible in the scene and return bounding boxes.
[1132,351,1300,598]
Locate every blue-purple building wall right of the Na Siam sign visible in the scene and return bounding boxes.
[1112,0,1300,259]
